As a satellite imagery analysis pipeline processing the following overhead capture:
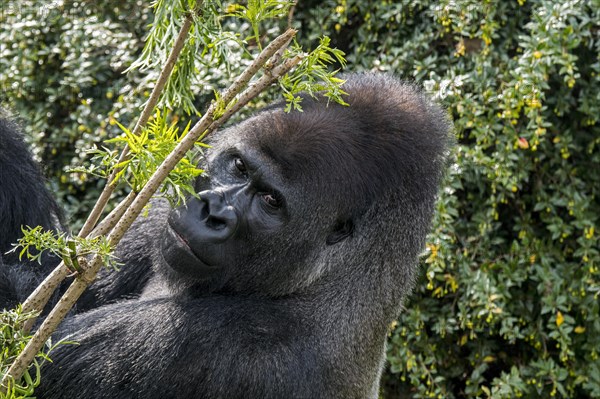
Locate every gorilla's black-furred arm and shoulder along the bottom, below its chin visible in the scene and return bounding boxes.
[36,296,338,399]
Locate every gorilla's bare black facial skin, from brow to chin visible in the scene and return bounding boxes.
[162,139,289,279]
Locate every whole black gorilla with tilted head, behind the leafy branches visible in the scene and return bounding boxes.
[0,73,452,399]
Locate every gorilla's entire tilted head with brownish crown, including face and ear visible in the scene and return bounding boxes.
[161,74,449,304]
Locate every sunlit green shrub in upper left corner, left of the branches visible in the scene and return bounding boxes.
[0,0,151,225]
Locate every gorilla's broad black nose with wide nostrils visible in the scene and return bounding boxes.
[198,190,238,240]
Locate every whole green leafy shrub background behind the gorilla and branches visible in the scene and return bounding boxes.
[0,0,600,398]
